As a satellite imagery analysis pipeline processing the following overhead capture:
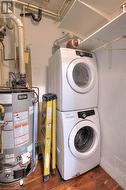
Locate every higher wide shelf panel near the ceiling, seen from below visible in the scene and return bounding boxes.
[59,0,109,39]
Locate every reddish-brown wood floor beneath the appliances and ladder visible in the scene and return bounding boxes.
[0,163,123,190]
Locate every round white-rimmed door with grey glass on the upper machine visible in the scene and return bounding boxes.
[67,59,96,93]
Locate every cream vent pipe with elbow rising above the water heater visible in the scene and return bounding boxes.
[10,14,25,75]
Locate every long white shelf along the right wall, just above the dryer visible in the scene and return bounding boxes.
[78,12,126,51]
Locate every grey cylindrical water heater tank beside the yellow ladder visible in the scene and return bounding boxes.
[0,89,35,183]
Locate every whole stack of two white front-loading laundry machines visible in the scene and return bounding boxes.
[48,48,100,180]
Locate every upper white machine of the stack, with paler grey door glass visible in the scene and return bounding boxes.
[48,48,98,111]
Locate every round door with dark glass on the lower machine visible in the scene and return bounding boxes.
[68,120,100,159]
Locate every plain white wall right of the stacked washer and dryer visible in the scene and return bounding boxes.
[96,40,126,189]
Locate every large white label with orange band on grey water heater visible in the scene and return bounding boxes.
[14,111,29,147]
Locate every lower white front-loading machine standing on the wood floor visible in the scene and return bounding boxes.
[57,108,100,180]
